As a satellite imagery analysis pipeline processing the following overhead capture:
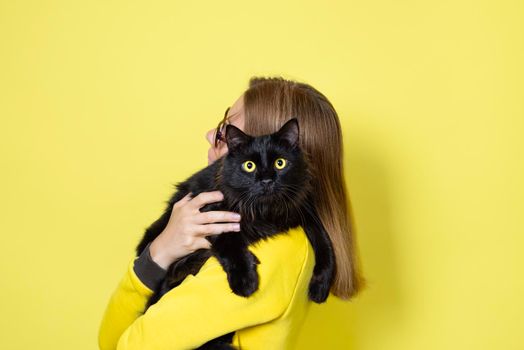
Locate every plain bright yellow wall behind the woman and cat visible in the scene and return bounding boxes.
[0,0,524,350]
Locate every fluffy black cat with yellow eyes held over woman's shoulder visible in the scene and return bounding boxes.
[136,118,335,349]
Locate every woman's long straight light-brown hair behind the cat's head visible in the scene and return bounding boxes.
[244,77,366,299]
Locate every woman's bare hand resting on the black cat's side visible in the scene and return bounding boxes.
[149,191,240,270]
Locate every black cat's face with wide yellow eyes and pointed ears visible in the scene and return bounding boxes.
[222,118,309,211]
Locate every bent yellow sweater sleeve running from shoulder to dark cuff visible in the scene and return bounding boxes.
[99,235,300,350]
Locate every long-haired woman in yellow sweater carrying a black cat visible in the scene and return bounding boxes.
[99,77,365,350]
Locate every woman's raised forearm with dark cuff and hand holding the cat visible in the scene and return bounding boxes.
[99,191,246,350]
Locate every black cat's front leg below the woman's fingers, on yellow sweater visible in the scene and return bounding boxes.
[211,232,260,297]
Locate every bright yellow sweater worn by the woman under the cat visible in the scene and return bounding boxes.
[98,227,315,350]
